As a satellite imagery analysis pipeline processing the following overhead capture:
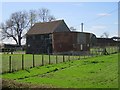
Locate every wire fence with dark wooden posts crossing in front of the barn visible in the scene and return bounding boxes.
[2,47,118,73]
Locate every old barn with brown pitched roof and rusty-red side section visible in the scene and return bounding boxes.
[26,20,95,54]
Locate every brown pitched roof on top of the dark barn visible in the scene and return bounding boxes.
[27,20,70,34]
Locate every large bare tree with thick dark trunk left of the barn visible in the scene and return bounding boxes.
[0,11,30,46]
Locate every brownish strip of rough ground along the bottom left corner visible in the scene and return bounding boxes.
[2,79,53,90]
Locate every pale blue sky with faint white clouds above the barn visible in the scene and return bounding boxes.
[0,0,118,43]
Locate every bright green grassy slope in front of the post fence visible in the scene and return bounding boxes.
[3,54,118,88]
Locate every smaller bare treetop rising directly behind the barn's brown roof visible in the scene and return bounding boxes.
[38,8,55,22]
